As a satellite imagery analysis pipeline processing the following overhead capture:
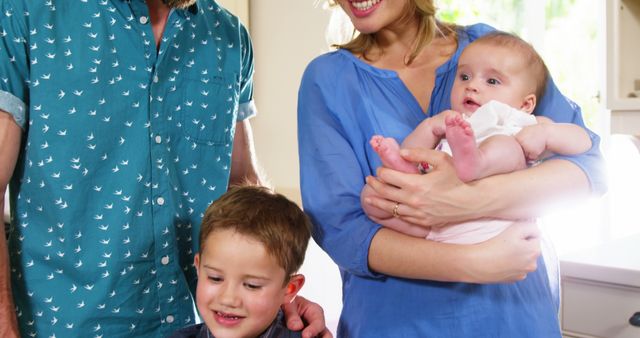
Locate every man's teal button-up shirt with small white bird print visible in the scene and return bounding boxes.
[0,0,254,337]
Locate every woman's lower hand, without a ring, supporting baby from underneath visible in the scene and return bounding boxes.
[465,220,541,283]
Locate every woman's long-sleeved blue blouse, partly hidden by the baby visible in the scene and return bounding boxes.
[298,25,605,338]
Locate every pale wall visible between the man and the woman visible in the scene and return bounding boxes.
[249,0,342,328]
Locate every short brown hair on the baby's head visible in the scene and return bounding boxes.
[472,31,549,102]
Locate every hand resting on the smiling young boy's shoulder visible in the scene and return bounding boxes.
[282,295,333,338]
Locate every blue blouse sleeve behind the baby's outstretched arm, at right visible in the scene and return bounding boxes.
[534,78,607,195]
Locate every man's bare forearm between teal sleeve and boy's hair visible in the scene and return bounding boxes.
[229,119,265,185]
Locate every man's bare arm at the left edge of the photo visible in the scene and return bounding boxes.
[0,110,22,337]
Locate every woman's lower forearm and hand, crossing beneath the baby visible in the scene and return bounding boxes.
[369,222,540,283]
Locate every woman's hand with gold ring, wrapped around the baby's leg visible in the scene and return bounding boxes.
[367,148,481,227]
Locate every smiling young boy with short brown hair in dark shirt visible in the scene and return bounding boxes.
[173,186,311,338]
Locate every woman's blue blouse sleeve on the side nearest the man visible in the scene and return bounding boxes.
[298,59,382,278]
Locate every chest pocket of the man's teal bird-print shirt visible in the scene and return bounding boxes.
[179,73,239,145]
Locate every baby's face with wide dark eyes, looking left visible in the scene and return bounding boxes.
[451,43,534,115]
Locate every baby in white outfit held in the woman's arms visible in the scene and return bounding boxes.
[361,32,591,243]
